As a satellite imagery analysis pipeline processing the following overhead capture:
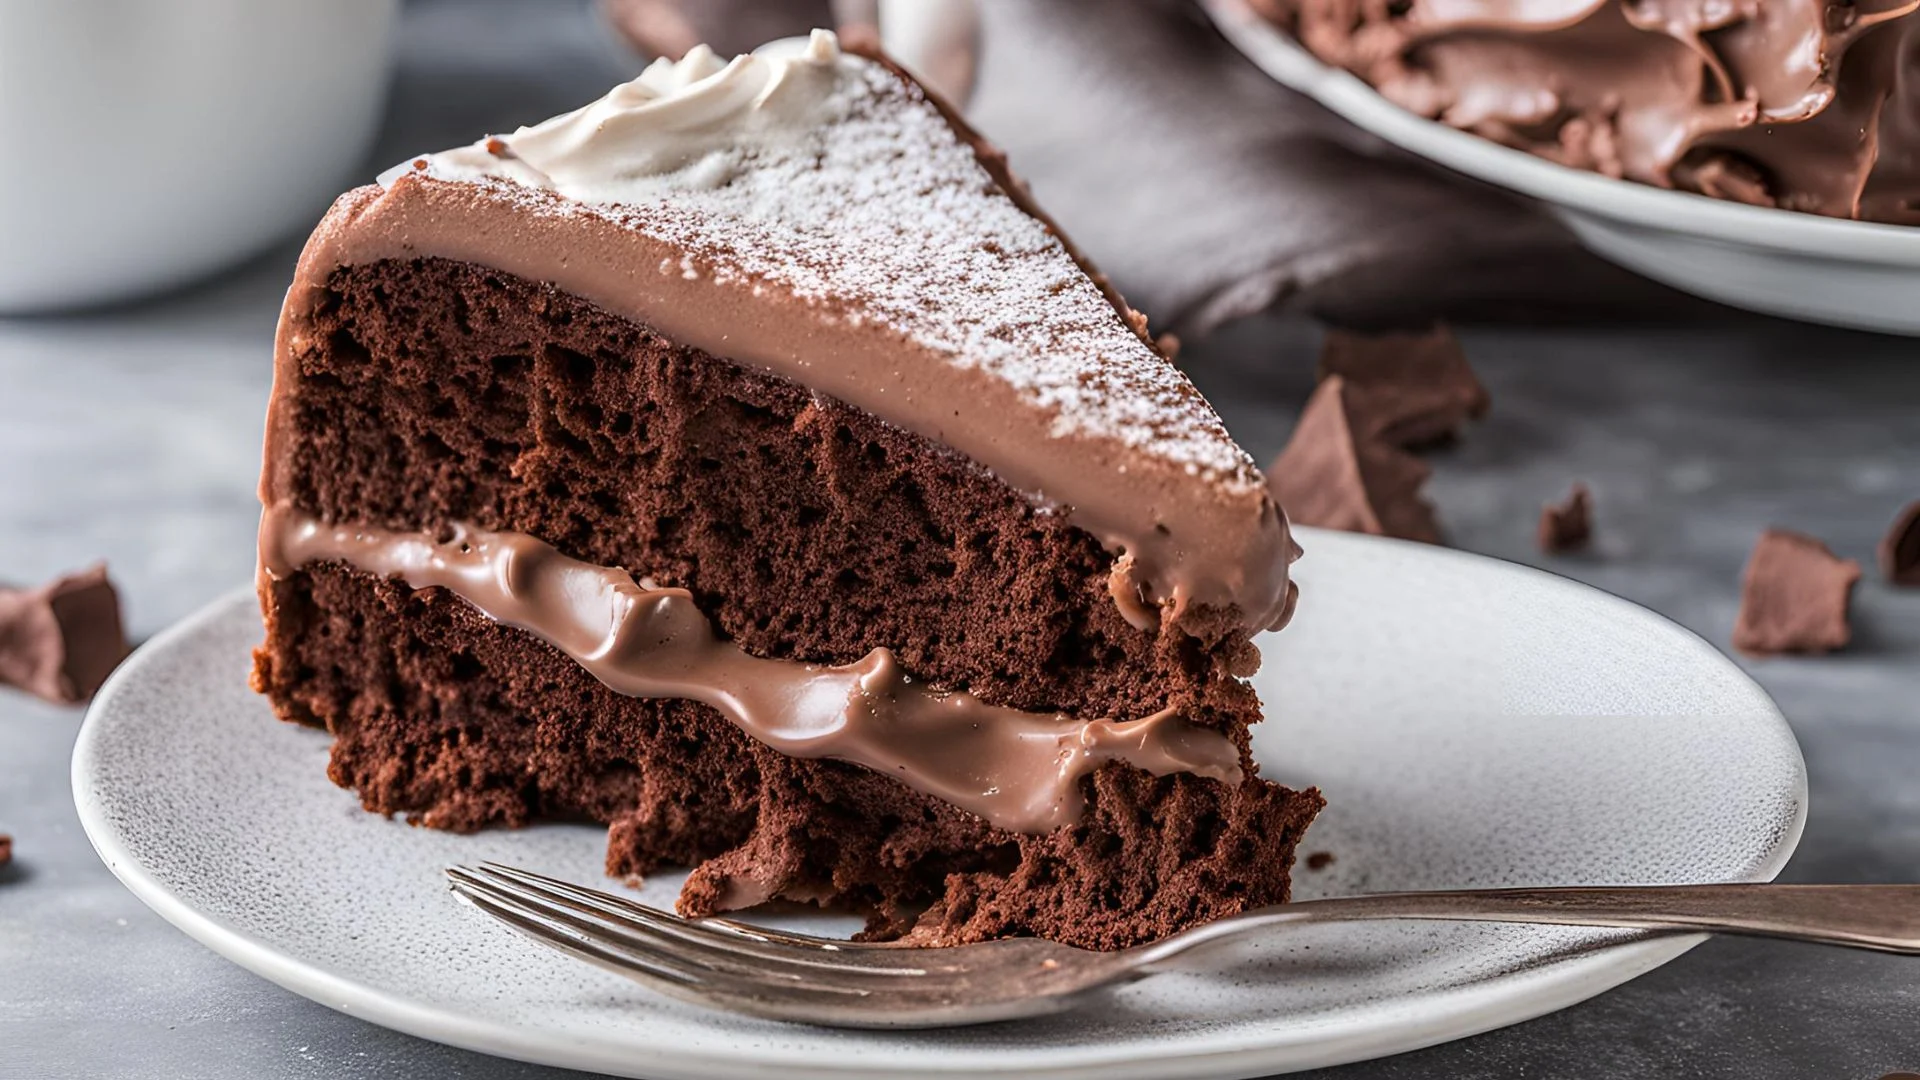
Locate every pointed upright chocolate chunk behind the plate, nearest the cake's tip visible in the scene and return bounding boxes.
[1267,375,1440,544]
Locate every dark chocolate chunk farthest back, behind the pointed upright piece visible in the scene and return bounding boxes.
[1319,327,1490,450]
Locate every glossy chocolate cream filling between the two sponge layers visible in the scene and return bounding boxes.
[259,505,1242,834]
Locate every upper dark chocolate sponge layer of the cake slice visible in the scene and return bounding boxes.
[282,259,1260,714]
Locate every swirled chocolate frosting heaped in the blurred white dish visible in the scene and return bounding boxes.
[1258,0,1920,223]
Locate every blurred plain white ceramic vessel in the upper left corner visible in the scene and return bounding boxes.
[0,0,397,313]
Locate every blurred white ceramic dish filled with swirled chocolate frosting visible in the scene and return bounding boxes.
[1202,0,1920,334]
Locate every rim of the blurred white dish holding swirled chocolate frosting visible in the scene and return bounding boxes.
[1200,0,1920,269]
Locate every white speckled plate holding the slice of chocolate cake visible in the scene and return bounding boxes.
[73,530,1807,1078]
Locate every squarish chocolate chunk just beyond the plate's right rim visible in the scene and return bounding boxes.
[1734,528,1860,655]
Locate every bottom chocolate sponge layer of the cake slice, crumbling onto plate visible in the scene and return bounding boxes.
[259,565,1321,947]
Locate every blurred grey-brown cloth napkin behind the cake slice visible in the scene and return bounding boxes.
[607,0,1705,340]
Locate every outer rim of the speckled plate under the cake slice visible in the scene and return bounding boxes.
[71,530,1809,1080]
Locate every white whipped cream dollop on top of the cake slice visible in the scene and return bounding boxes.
[380,31,854,204]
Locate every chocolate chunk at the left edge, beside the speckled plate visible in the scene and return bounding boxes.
[0,565,127,705]
